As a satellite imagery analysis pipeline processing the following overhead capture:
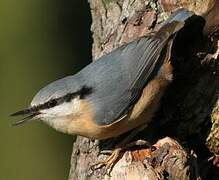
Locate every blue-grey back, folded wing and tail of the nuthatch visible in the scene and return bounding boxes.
[82,10,192,125]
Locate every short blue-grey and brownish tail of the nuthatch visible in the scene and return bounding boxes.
[157,8,194,37]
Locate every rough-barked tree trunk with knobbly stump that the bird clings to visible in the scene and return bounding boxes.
[69,0,219,180]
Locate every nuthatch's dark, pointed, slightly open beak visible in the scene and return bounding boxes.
[10,108,40,126]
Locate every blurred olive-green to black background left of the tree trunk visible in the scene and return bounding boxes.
[0,0,92,180]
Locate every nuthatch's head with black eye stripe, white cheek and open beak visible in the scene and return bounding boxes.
[11,76,92,131]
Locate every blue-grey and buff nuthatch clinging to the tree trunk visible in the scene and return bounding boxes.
[12,9,194,172]
